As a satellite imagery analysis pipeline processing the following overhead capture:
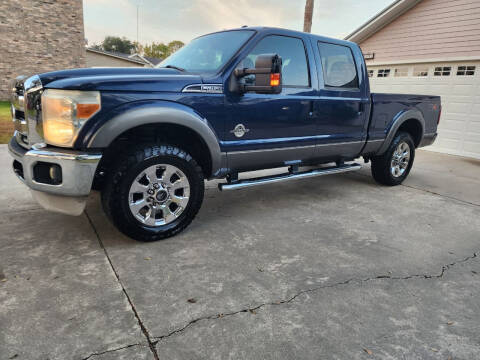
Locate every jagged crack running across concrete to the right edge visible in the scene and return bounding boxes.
[155,252,478,344]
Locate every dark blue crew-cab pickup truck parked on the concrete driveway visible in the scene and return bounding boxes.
[9,27,441,241]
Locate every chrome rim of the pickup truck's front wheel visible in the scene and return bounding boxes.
[128,164,190,226]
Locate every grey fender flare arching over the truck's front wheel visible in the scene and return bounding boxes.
[88,101,225,177]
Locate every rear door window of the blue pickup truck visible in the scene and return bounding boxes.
[318,42,358,89]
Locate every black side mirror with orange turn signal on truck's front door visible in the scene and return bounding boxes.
[230,54,282,94]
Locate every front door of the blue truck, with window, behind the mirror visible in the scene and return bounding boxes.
[222,34,317,170]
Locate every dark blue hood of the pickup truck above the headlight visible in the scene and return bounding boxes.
[39,68,202,92]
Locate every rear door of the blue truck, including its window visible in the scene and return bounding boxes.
[315,41,368,159]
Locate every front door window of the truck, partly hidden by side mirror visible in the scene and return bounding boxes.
[238,35,310,87]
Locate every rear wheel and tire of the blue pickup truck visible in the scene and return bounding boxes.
[371,132,415,186]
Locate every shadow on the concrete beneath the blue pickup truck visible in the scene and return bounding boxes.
[85,173,382,246]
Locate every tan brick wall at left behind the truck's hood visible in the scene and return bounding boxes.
[0,0,85,100]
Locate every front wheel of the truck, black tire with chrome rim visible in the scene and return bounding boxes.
[102,144,204,241]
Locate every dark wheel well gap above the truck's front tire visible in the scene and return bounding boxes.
[93,124,212,189]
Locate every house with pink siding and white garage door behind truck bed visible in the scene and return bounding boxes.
[346,0,480,158]
